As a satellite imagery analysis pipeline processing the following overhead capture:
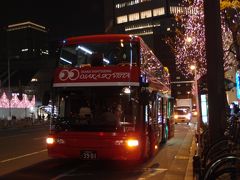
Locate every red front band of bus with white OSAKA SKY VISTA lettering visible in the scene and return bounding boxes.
[54,67,140,87]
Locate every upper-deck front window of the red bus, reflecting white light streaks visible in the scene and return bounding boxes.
[59,42,139,67]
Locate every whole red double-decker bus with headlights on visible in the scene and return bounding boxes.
[47,34,173,160]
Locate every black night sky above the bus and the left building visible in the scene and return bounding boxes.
[0,0,104,39]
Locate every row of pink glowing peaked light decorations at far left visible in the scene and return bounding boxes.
[0,92,36,108]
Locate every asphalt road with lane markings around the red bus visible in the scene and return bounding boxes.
[0,121,194,180]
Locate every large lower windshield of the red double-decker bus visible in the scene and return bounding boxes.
[54,87,139,132]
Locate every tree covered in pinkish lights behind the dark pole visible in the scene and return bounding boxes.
[171,0,237,77]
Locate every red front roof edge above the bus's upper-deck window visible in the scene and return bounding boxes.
[63,34,141,45]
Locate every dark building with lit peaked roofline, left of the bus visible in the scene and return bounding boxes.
[6,21,48,59]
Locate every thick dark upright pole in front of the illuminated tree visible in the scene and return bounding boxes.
[204,0,226,144]
